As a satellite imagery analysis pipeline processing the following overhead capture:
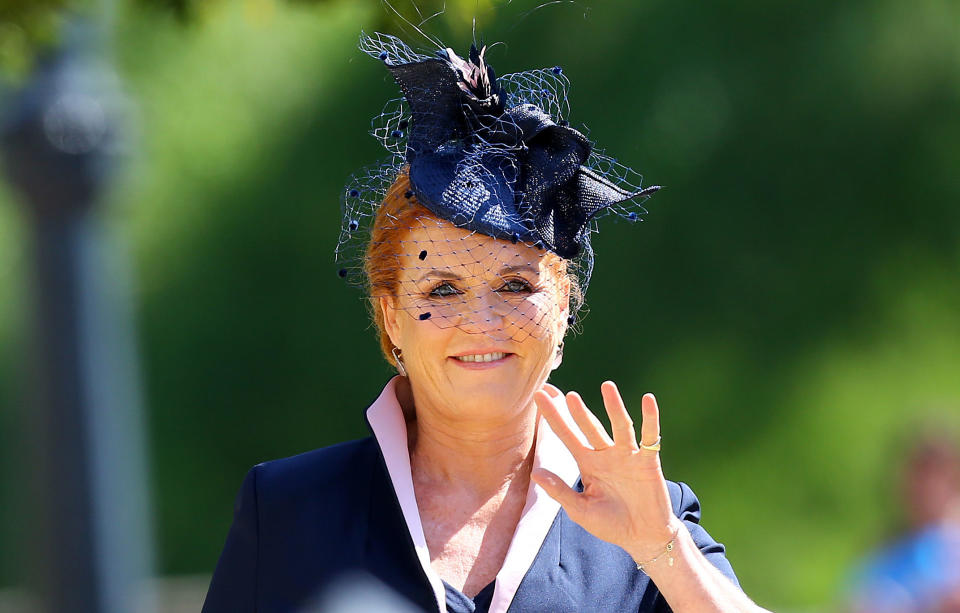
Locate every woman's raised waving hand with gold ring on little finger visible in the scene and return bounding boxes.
[531,381,682,561]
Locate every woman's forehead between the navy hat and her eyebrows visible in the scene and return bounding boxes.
[396,217,548,275]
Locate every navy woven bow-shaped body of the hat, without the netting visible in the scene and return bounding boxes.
[387,46,659,259]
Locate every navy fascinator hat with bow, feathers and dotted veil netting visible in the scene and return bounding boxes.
[337,33,660,320]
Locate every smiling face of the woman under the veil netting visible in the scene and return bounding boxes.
[380,217,569,420]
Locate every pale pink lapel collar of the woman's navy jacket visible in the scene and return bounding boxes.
[367,377,580,613]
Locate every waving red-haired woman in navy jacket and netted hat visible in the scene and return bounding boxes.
[204,35,761,613]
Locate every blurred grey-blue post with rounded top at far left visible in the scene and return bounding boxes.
[2,11,151,613]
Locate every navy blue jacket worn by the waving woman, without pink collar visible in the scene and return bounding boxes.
[203,437,737,613]
